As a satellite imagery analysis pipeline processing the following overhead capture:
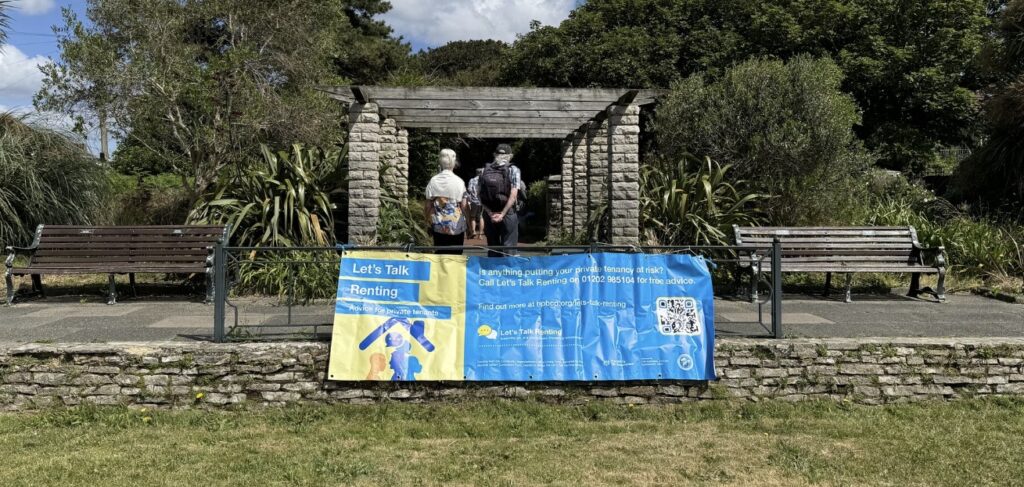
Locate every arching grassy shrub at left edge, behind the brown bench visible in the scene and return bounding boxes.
[0,114,109,247]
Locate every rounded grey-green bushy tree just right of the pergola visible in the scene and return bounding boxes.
[653,55,870,224]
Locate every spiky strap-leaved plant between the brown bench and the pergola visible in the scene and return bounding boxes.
[188,144,344,247]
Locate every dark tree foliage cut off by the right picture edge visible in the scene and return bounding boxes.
[954,0,1024,209]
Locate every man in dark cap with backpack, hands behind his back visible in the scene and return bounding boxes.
[477,143,522,257]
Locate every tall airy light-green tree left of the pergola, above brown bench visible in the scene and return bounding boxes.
[36,0,409,197]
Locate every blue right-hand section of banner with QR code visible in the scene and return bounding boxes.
[464,254,715,381]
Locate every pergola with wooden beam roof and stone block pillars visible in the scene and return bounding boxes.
[324,86,662,244]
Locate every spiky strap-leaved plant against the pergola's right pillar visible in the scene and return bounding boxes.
[640,154,767,245]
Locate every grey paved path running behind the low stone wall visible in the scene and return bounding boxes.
[0,295,1024,342]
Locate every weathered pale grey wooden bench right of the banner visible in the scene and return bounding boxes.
[733,225,946,303]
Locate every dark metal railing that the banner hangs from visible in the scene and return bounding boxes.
[207,239,782,342]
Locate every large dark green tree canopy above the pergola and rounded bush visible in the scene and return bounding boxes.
[503,0,988,172]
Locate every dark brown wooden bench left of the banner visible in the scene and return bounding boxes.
[5,225,227,305]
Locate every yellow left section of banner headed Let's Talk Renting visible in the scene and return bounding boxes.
[328,251,467,381]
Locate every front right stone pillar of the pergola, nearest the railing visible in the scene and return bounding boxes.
[607,104,640,245]
